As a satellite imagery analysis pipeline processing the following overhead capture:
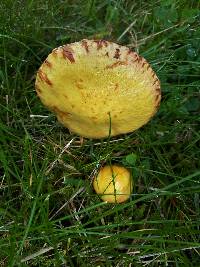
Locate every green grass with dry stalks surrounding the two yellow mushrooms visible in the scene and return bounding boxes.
[0,0,200,267]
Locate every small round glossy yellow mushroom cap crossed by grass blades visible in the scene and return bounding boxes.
[93,165,133,203]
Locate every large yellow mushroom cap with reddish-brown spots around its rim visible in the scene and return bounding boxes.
[35,40,161,138]
